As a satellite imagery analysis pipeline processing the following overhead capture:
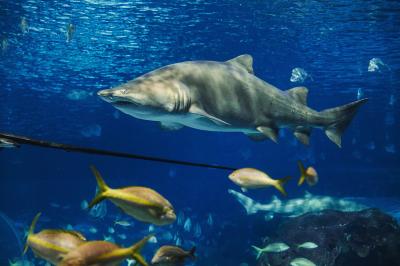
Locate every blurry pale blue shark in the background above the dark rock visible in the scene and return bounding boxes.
[228,189,369,219]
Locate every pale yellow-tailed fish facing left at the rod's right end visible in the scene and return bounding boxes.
[229,168,291,196]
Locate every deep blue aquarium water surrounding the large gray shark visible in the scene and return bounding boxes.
[0,0,400,265]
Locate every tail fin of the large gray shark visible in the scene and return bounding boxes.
[320,99,368,147]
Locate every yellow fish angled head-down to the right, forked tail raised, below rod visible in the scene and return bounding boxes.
[88,166,176,225]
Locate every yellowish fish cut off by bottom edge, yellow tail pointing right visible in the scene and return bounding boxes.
[57,235,152,266]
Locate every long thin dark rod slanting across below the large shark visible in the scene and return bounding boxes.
[0,132,237,170]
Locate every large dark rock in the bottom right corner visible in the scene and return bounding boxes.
[258,209,400,266]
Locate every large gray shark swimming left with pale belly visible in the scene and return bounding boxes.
[98,55,367,147]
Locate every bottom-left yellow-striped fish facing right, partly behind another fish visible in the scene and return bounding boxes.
[23,213,86,264]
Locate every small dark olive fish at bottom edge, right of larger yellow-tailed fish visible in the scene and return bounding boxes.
[151,246,196,266]
